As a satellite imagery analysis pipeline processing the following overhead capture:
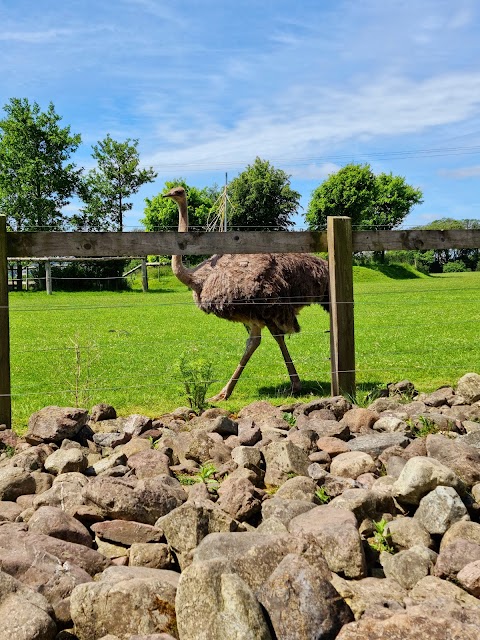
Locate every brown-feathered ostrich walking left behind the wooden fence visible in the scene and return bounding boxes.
[163,186,329,402]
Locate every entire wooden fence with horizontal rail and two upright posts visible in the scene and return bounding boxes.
[0,216,480,426]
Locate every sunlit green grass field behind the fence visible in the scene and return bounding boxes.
[10,267,480,431]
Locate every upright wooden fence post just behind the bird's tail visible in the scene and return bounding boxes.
[327,217,355,396]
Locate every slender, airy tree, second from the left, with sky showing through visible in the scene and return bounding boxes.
[77,134,157,231]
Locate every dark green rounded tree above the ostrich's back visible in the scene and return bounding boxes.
[228,157,300,231]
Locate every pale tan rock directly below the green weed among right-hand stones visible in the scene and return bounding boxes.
[380,545,437,589]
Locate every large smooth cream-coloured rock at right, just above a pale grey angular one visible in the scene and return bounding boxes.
[393,456,463,504]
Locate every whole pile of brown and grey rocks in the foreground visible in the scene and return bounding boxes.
[0,373,480,640]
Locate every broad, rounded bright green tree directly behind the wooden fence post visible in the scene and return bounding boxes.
[306,164,422,229]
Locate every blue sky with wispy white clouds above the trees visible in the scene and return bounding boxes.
[0,0,480,228]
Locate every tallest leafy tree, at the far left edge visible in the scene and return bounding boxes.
[0,98,82,231]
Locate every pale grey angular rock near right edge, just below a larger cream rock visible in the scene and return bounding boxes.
[414,486,470,534]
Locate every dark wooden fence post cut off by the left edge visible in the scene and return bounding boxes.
[0,216,12,429]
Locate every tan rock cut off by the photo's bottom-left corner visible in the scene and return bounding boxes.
[0,571,57,640]
